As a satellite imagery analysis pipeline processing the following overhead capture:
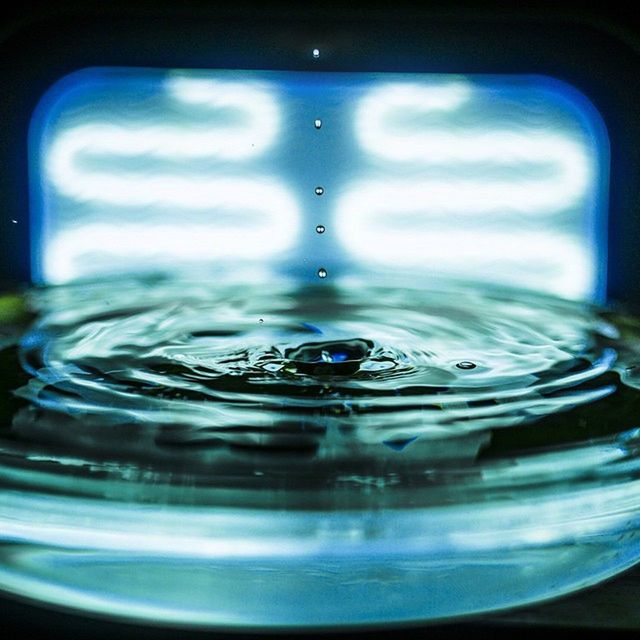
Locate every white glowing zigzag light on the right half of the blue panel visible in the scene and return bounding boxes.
[340,80,596,298]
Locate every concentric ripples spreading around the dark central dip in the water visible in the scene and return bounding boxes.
[3,281,636,484]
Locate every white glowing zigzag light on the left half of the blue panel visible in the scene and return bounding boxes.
[42,73,300,283]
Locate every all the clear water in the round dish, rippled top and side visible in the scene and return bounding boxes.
[0,279,640,626]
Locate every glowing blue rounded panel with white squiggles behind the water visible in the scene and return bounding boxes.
[31,68,608,299]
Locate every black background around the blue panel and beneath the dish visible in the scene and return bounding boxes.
[0,0,640,640]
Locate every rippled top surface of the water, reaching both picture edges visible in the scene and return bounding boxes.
[2,279,640,505]
